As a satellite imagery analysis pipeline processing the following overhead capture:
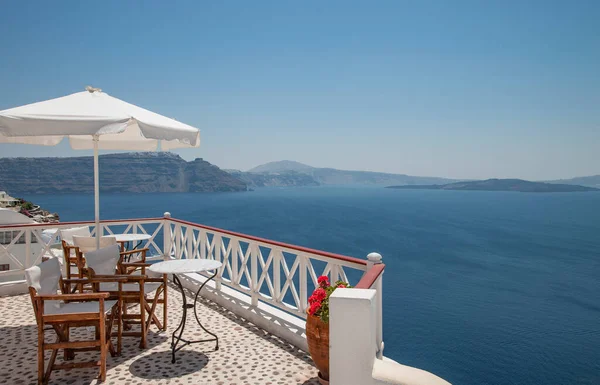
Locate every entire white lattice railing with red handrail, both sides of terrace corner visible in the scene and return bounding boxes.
[0,213,383,341]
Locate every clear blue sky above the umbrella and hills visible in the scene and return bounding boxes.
[0,0,600,179]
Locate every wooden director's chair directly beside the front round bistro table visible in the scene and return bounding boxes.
[85,245,167,349]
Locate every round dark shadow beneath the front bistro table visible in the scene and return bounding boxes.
[129,350,208,379]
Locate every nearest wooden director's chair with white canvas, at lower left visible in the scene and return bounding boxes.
[25,258,125,384]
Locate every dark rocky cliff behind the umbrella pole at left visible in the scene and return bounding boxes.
[0,152,247,195]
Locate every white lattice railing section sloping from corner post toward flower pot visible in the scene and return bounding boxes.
[165,217,367,318]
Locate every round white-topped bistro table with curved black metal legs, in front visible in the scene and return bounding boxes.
[150,259,223,363]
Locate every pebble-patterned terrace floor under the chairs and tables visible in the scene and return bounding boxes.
[0,287,318,385]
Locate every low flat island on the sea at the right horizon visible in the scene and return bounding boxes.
[387,179,600,193]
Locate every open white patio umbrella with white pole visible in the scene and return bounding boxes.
[0,86,200,246]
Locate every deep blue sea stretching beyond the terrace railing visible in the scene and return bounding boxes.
[25,187,600,385]
